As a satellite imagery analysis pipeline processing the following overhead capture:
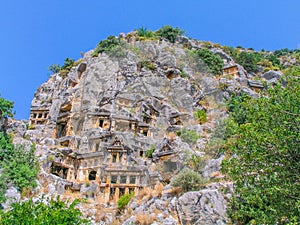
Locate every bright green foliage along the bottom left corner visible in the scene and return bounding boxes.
[0,197,89,225]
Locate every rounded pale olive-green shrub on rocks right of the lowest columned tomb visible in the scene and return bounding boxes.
[171,167,207,192]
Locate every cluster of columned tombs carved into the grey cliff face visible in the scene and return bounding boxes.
[30,97,186,202]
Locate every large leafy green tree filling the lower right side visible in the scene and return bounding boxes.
[222,77,300,224]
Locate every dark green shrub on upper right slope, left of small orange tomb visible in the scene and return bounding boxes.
[195,48,224,75]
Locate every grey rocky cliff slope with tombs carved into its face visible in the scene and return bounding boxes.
[6,29,281,224]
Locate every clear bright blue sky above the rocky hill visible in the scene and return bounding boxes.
[0,0,300,119]
